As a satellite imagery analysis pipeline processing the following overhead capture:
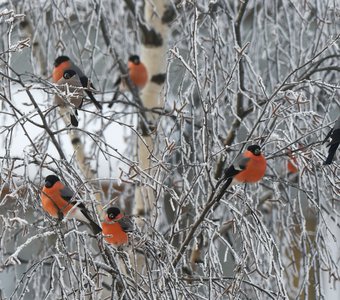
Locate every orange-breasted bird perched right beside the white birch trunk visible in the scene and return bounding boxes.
[109,55,148,107]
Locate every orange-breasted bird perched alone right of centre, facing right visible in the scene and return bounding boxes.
[224,145,267,188]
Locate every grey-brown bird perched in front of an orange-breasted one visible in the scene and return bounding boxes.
[54,70,84,127]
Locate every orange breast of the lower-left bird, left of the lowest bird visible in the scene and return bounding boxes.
[41,182,73,218]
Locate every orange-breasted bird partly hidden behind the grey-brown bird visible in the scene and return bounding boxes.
[52,55,102,109]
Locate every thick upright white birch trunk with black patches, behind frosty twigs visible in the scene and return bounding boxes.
[135,0,174,217]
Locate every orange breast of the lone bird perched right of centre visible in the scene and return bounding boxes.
[235,151,267,183]
